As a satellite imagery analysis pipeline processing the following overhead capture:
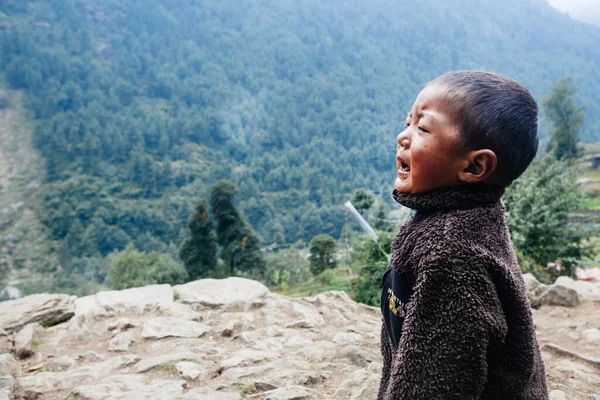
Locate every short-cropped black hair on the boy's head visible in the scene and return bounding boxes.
[430,71,539,186]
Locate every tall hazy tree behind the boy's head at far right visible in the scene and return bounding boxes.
[542,76,585,160]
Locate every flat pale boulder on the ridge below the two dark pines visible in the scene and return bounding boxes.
[173,277,269,308]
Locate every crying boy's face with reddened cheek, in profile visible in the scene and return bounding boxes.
[394,83,469,193]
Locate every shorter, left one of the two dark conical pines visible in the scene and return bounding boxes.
[179,200,217,280]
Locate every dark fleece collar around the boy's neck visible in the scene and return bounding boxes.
[392,185,504,213]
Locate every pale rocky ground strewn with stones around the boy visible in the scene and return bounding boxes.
[0,278,600,400]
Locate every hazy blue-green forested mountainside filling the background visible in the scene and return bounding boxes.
[0,0,600,290]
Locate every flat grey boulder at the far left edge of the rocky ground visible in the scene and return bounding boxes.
[0,294,75,332]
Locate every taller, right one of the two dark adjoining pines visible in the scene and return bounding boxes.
[210,180,265,275]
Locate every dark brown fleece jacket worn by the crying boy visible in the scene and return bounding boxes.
[378,186,548,400]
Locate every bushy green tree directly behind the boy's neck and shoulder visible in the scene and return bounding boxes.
[505,154,586,279]
